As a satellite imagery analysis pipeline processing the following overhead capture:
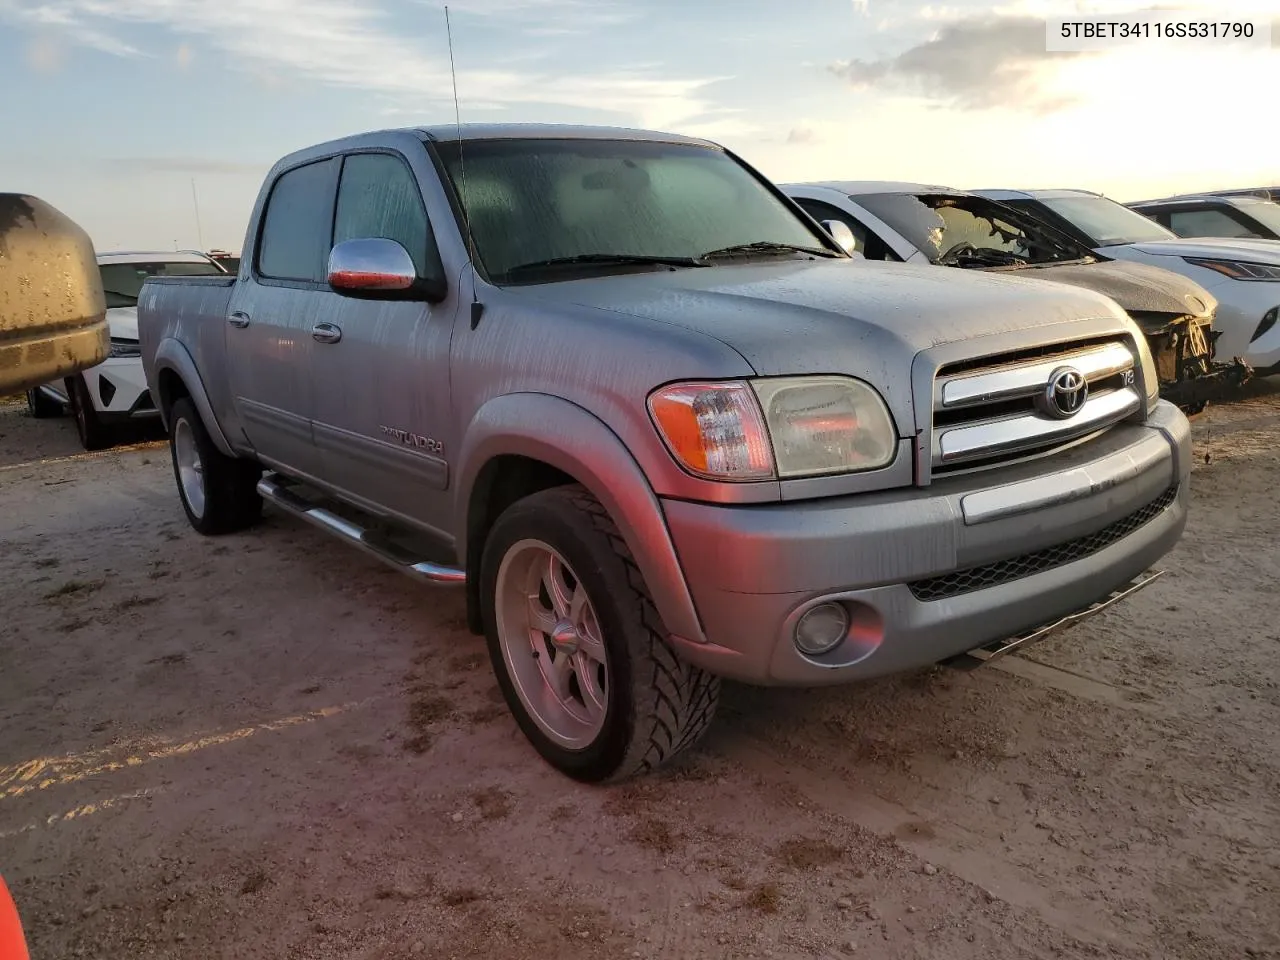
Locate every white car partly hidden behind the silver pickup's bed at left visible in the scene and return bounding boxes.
[27,251,227,451]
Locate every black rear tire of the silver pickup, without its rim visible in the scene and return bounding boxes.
[169,397,262,536]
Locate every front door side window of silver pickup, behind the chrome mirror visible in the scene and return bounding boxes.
[333,154,434,275]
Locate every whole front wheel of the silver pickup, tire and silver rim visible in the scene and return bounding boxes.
[480,486,719,782]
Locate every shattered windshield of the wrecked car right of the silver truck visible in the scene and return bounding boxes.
[851,193,1089,268]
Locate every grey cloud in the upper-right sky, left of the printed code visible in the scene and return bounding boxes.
[828,8,1085,114]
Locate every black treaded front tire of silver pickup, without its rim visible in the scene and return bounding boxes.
[480,485,721,782]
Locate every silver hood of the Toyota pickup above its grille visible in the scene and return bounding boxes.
[535,260,1134,424]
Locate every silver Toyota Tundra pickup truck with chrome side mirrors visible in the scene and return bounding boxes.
[138,125,1190,781]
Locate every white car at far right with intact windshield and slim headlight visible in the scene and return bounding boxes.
[972,189,1280,376]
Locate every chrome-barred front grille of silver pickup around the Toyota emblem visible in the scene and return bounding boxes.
[929,337,1143,476]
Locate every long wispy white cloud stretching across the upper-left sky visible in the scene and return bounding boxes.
[0,0,722,127]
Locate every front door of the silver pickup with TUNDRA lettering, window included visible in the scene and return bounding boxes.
[311,152,458,542]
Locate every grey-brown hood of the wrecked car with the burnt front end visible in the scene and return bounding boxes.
[993,260,1217,317]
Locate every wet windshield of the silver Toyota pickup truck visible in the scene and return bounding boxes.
[436,138,838,283]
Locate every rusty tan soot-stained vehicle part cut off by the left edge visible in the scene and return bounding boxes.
[0,193,110,393]
